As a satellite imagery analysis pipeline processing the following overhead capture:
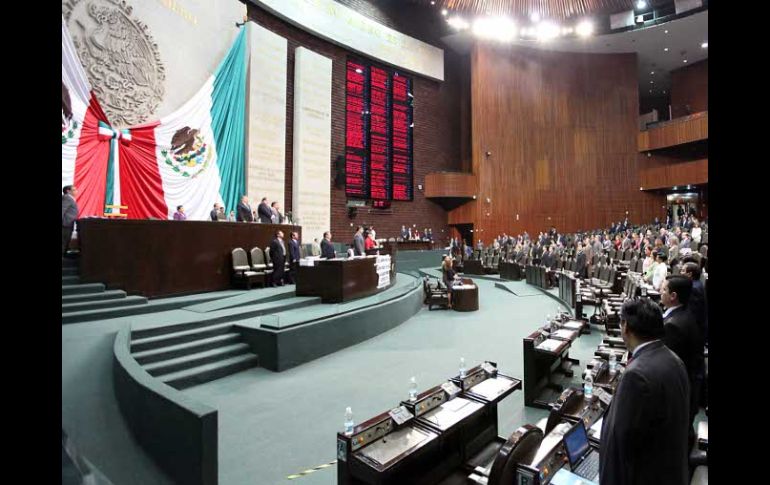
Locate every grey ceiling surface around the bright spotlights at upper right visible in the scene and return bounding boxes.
[442,10,708,97]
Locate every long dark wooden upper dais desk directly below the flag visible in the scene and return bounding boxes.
[78,219,302,298]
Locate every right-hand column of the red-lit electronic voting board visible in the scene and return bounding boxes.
[391,73,414,200]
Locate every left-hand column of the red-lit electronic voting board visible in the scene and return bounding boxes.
[345,61,369,199]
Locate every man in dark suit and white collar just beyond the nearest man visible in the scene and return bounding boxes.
[660,275,705,446]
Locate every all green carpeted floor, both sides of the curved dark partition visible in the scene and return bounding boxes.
[62,268,702,485]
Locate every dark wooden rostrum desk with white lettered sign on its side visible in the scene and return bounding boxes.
[296,256,396,303]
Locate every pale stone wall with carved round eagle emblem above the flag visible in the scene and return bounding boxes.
[62,0,245,128]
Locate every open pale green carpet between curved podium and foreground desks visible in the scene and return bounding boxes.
[185,280,601,485]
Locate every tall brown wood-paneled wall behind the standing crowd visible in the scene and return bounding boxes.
[464,44,660,240]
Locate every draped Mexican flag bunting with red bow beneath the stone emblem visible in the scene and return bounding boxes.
[62,19,248,220]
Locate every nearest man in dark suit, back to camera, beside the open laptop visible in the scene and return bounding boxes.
[599,298,690,485]
